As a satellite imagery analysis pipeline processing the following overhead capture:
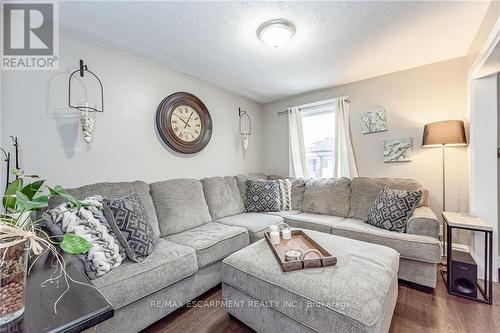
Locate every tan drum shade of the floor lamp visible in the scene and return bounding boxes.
[422,120,467,147]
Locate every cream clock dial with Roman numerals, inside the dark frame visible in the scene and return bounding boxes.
[170,105,203,142]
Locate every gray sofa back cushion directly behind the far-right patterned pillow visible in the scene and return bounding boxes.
[349,177,422,220]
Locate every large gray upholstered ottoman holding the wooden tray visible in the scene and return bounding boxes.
[222,230,399,333]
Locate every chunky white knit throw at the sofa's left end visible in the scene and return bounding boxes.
[48,195,126,279]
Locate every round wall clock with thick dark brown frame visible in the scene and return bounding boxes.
[156,92,212,154]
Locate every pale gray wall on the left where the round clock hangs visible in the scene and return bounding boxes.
[1,33,263,187]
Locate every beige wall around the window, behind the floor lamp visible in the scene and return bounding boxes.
[263,58,469,226]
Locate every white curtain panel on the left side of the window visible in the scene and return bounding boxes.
[288,107,309,178]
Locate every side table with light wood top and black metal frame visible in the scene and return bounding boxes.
[441,212,493,304]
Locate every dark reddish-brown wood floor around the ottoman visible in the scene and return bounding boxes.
[144,264,500,333]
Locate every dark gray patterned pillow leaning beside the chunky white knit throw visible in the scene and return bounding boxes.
[104,193,158,262]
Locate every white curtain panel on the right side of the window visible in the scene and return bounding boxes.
[333,97,358,178]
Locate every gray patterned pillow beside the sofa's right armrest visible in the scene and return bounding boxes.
[365,187,422,232]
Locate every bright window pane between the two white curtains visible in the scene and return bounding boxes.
[301,105,335,178]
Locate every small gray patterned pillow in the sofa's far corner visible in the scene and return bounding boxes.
[245,179,281,212]
